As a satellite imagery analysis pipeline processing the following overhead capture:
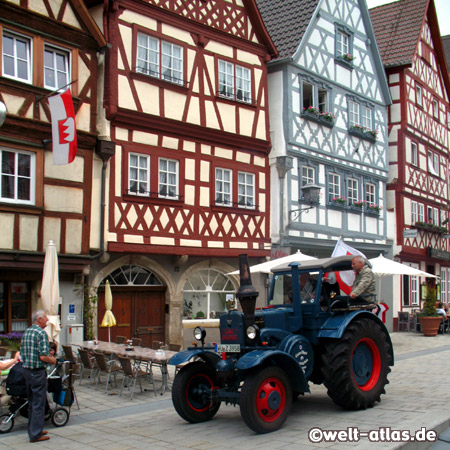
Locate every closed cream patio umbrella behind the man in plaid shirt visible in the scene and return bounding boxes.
[41,241,61,343]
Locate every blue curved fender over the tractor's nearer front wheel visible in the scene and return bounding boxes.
[237,350,309,392]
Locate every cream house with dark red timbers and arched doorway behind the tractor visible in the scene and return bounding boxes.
[87,0,276,345]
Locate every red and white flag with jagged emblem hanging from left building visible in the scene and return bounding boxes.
[48,89,77,165]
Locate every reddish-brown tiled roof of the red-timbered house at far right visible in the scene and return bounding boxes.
[370,0,429,67]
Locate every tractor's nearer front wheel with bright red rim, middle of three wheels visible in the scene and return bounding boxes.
[240,366,292,433]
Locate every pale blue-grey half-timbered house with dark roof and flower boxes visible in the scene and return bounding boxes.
[258,0,390,257]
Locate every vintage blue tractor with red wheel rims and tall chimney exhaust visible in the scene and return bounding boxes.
[170,255,394,433]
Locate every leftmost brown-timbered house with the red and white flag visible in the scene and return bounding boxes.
[0,0,106,341]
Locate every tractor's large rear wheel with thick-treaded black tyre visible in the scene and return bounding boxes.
[322,319,391,410]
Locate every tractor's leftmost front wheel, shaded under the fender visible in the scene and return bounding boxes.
[172,361,220,423]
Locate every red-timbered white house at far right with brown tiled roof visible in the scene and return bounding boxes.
[370,0,450,326]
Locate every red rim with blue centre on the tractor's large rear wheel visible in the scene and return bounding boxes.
[352,337,381,391]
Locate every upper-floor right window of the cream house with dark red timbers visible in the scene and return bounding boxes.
[219,60,252,103]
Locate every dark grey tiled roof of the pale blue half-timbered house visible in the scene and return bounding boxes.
[256,0,320,58]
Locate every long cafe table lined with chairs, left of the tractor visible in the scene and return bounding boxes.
[80,341,177,395]
